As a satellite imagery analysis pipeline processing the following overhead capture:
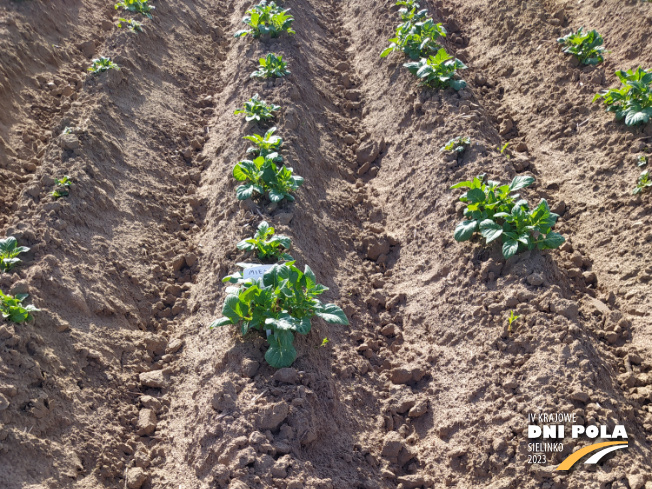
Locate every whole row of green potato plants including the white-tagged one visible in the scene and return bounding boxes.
[210,0,349,368]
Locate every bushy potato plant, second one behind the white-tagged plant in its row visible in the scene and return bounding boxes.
[233,153,303,202]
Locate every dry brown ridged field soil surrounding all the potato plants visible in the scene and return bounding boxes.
[0,0,652,489]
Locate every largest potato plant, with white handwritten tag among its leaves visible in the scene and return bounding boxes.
[210,262,349,368]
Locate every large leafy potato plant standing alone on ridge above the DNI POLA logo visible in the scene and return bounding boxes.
[451,175,564,259]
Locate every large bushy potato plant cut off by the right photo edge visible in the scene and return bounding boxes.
[593,67,652,126]
